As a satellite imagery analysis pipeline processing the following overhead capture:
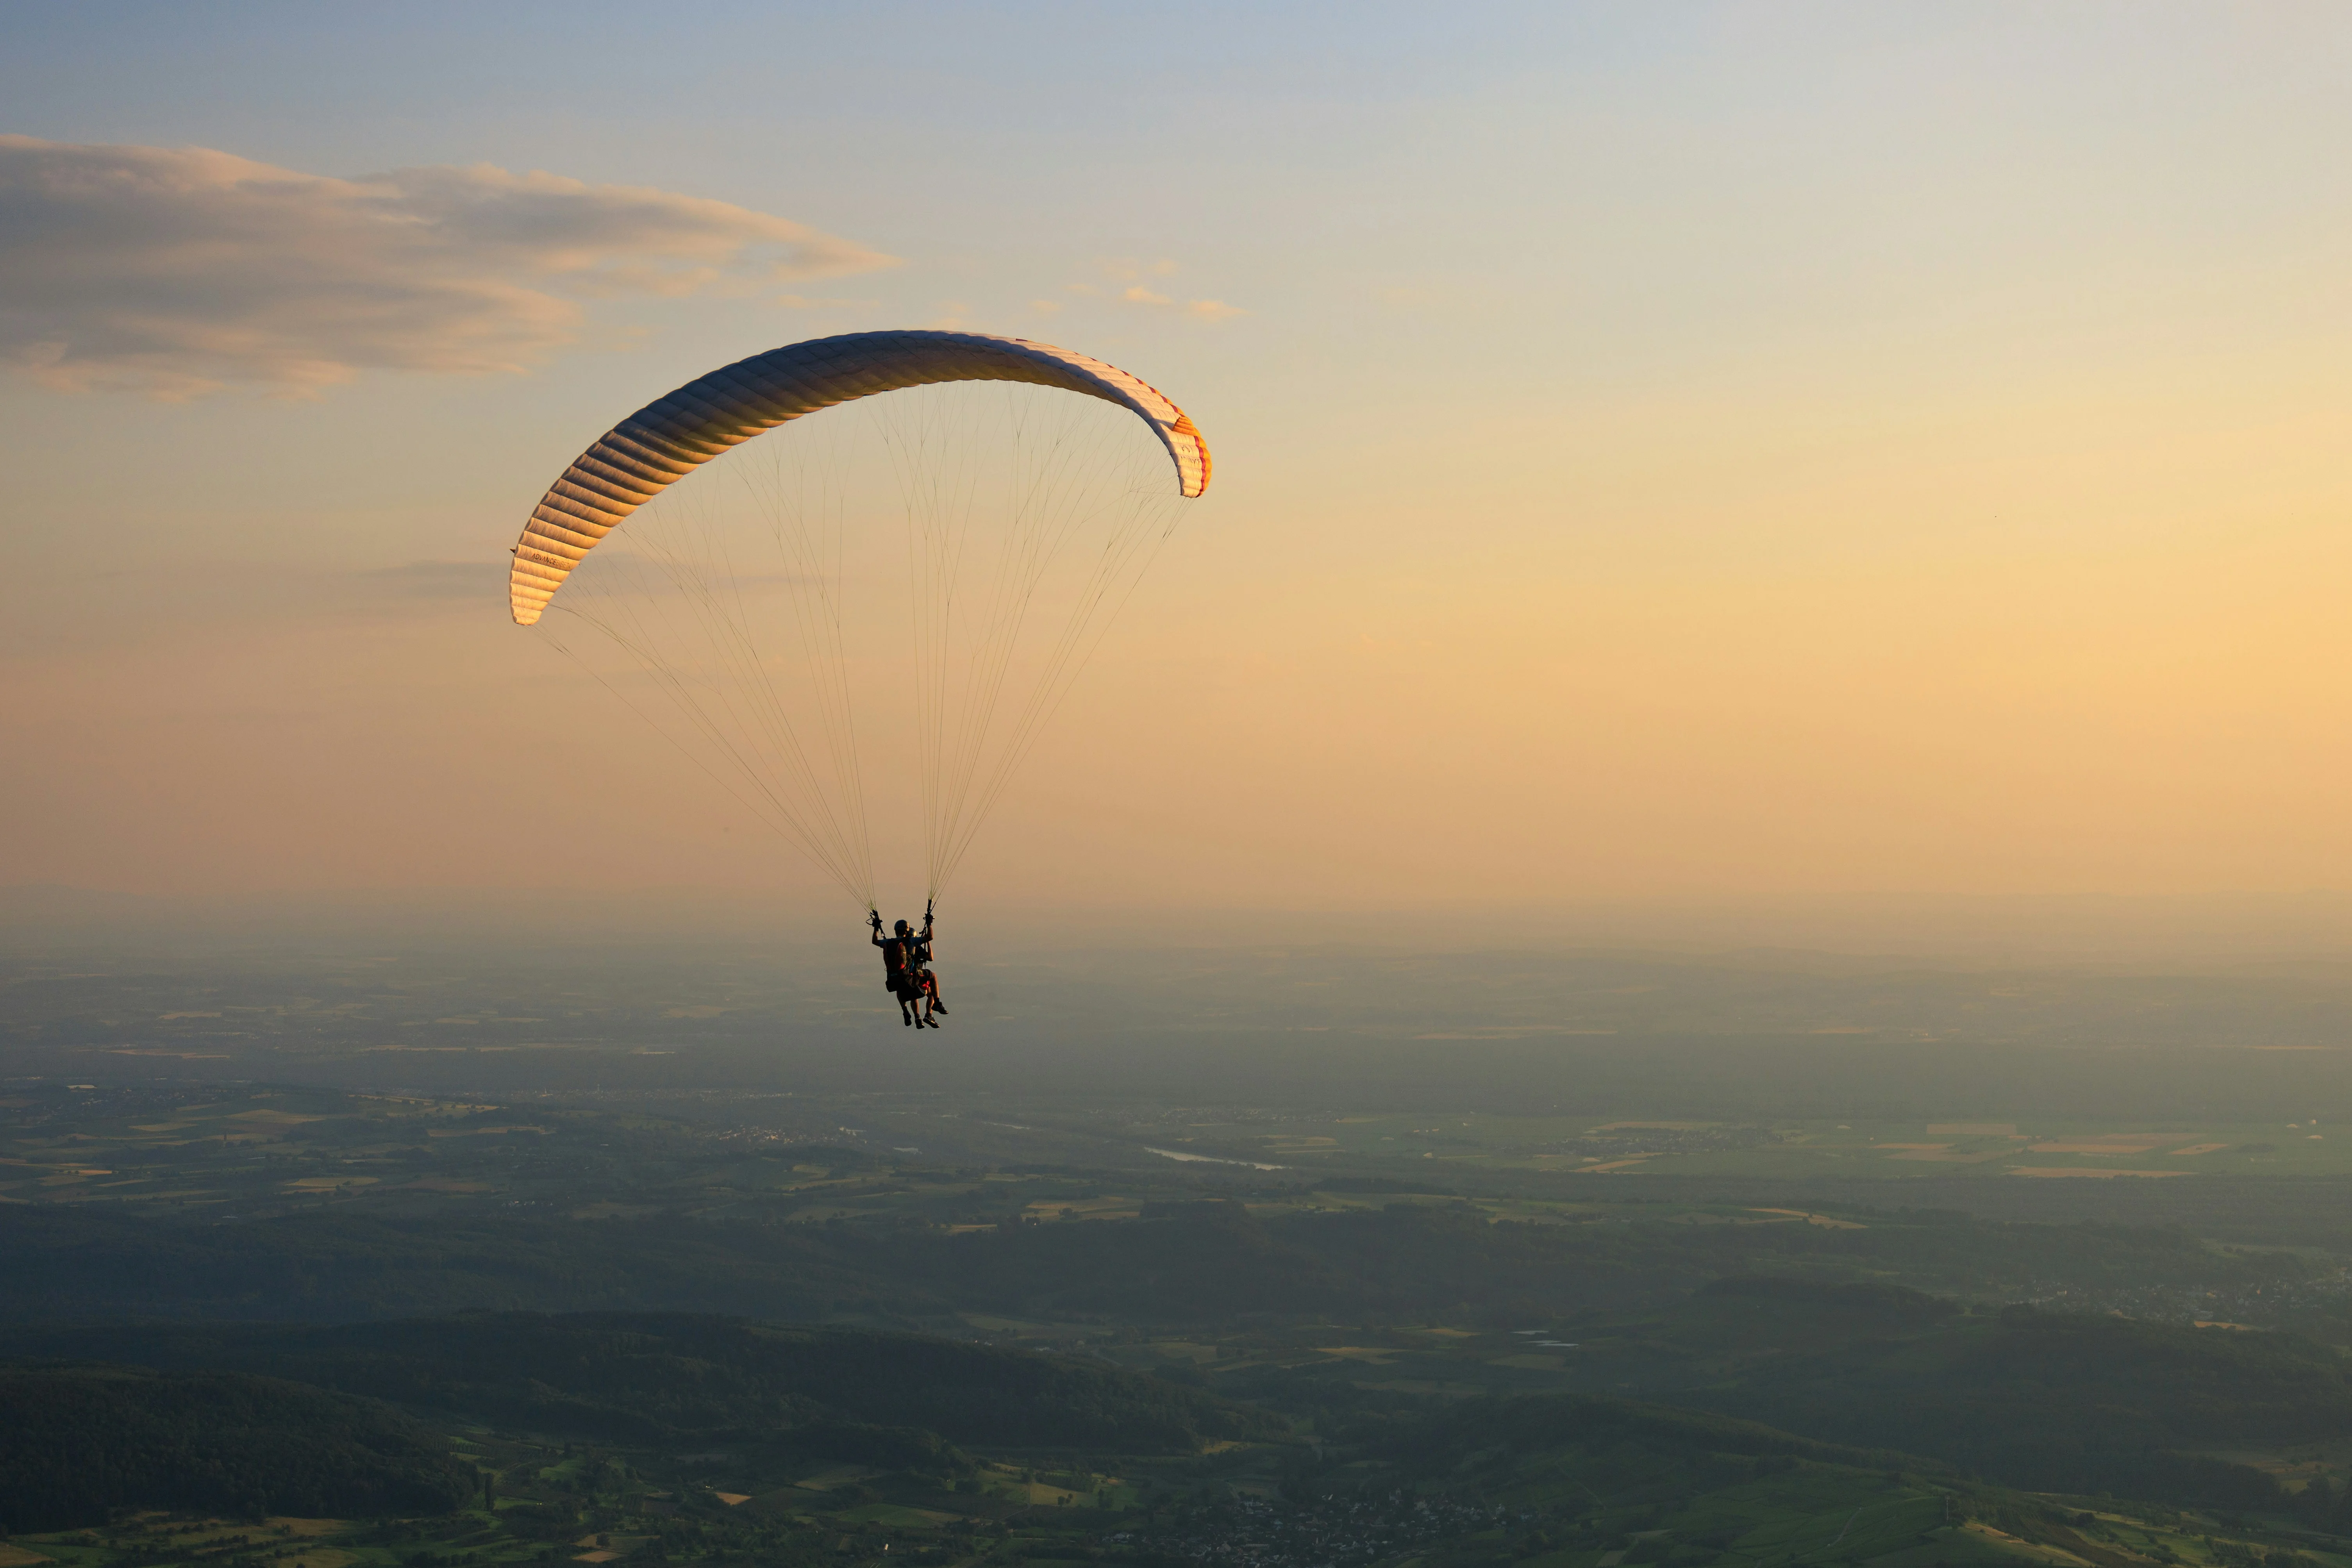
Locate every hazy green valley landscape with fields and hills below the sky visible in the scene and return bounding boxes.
[14,907,2352,1568]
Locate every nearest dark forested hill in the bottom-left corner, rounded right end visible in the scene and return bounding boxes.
[0,1368,475,1530]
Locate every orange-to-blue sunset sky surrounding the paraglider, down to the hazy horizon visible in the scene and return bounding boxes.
[0,0,2352,926]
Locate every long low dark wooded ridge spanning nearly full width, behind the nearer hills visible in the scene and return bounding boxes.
[0,1201,2277,1328]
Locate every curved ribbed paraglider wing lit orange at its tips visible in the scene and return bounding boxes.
[508,332,1209,625]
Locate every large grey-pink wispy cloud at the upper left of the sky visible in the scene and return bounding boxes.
[0,136,891,397]
